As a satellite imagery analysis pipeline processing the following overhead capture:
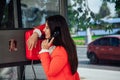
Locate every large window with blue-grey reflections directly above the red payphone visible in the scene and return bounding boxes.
[21,0,60,28]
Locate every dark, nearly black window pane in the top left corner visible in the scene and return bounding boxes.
[0,0,14,29]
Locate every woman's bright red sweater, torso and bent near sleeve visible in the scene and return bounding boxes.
[38,46,80,80]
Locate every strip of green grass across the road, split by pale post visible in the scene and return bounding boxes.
[72,36,102,45]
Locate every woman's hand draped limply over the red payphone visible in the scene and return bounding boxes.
[27,32,38,50]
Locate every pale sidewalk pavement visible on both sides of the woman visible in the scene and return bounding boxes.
[25,65,120,80]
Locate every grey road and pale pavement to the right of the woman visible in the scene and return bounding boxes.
[77,46,120,80]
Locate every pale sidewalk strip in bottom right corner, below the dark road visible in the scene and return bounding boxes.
[78,68,120,80]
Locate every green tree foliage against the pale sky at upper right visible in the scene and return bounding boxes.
[68,0,120,30]
